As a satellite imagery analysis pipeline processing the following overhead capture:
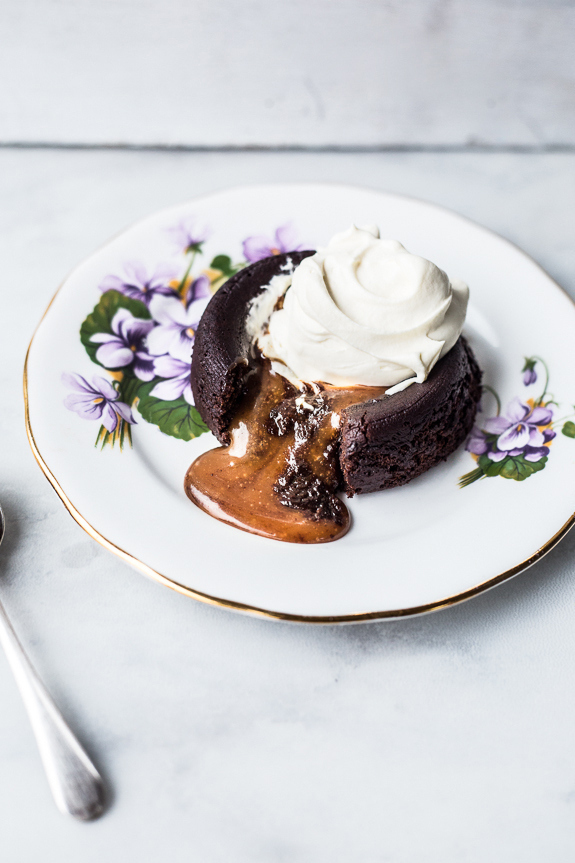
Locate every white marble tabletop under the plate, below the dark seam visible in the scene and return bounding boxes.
[0,150,575,863]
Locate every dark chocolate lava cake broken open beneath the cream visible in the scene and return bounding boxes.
[192,251,481,502]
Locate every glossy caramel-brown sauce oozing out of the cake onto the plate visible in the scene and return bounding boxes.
[184,361,385,543]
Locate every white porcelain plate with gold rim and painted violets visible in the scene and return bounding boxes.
[26,184,575,622]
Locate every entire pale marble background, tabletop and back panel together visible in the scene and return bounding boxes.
[0,0,575,863]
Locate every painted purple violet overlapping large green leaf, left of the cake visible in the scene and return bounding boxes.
[90,308,155,381]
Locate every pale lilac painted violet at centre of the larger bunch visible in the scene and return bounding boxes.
[148,275,211,363]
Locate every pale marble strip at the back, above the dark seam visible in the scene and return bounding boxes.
[0,0,575,146]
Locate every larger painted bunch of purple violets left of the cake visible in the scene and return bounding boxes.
[62,217,302,448]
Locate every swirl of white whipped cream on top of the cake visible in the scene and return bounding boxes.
[248,226,469,394]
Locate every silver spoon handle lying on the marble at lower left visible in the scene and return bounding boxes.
[0,508,104,821]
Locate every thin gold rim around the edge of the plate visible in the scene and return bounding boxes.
[23,184,575,625]
